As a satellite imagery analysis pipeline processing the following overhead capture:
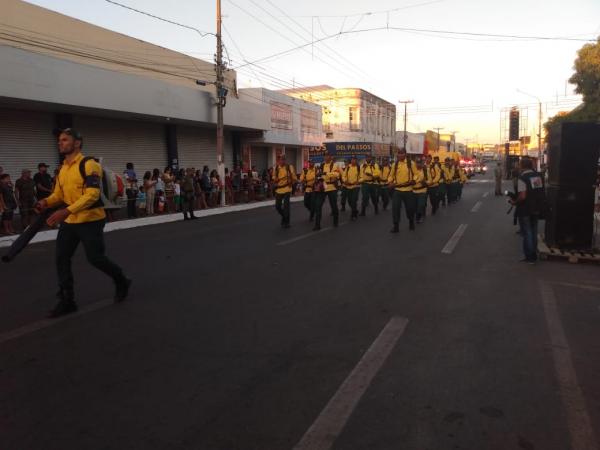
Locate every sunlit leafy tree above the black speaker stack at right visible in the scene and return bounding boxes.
[544,37,600,131]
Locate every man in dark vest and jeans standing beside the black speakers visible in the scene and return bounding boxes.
[513,157,546,264]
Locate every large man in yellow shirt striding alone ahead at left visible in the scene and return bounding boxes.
[36,128,131,317]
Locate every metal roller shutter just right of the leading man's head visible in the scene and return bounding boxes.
[73,116,168,180]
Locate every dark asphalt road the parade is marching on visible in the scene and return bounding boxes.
[0,170,600,450]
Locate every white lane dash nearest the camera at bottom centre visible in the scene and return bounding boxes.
[294,317,408,450]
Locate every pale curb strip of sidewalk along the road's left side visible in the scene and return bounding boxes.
[0,196,303,248]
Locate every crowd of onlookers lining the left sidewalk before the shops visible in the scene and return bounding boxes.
[0,163,302,235]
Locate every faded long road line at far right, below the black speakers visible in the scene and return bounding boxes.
[538,280,598,450]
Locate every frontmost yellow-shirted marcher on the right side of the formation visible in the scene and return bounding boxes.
[388,148,417,233]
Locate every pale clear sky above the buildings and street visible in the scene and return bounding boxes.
[23,0,600,143]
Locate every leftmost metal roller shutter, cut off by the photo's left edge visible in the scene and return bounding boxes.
[0,108,59,183]
